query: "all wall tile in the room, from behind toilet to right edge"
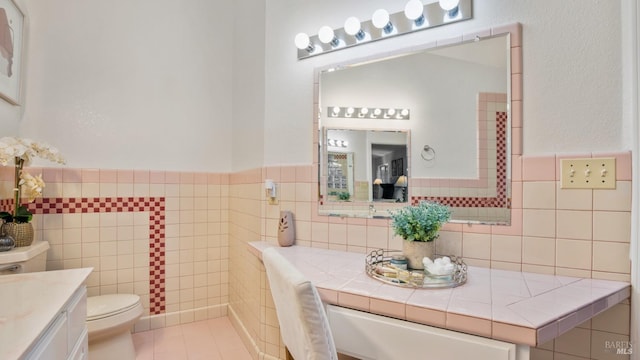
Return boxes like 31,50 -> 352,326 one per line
0,153 -> 631,360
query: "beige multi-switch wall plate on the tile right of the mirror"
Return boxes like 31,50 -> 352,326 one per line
560,158 -> 616,189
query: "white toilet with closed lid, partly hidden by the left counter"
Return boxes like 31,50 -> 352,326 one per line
0,241 -> 144,360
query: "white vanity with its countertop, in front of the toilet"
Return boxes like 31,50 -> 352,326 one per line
0,268 -> 93,360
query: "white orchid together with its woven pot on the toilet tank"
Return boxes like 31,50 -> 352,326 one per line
0,137 -> 64,246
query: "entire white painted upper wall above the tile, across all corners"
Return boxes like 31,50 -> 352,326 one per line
0,0 -> 632,171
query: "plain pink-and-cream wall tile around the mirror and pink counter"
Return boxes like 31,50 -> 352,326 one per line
229,153 -> 631,360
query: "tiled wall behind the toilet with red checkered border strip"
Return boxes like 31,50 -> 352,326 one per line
0,167 -> 229,331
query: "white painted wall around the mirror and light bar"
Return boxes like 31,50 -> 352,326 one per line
265,0 -> 632,165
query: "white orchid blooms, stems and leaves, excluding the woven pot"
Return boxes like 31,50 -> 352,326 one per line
0,137 -> 64,223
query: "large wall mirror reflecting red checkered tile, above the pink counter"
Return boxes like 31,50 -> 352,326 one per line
315,28 -> 512,224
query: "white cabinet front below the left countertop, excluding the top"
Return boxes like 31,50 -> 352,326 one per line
23,285 -> 89,360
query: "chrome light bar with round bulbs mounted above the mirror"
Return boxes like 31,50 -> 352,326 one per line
295,0 -> 473,60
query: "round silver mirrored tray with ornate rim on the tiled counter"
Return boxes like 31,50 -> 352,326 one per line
365,249 -> 467,289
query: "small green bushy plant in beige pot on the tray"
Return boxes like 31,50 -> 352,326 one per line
391,201 -> 451,269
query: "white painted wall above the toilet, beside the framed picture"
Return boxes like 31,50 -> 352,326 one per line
8,0 -> 234,171
